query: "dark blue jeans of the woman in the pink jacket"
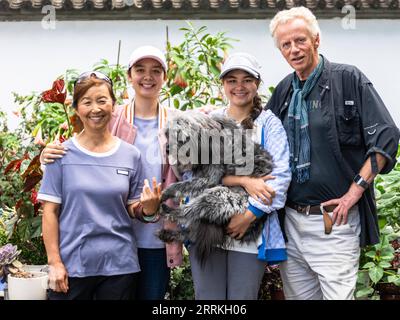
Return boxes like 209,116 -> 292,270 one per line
135,248 -> 169,300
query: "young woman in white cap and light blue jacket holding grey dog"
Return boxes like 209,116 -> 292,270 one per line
189,53 -> 291,300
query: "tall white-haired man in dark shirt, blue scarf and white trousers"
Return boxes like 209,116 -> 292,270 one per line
267,7 -> 399,300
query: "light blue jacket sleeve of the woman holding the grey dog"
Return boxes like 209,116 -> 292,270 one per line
248,111 -> 292,217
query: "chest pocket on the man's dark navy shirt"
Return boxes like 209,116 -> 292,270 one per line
336,101 -> 361,146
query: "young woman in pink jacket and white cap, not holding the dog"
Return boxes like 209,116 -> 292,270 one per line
41,46 -> 182,300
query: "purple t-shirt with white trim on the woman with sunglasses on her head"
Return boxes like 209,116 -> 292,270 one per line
38,138 -> 143,277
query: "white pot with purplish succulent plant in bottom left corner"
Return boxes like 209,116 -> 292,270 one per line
0,244 -> 48,300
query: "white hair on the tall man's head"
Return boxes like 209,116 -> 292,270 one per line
269,7 -> 321,48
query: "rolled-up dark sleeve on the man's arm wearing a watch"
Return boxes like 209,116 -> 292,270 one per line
360,76 -> 400,173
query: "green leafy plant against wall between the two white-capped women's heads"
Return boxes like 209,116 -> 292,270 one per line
162,22 -> 236,110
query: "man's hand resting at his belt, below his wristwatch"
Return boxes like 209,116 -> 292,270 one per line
322,183 -> 364,226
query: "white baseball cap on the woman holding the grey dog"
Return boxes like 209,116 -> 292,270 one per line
219,52 -> 261,79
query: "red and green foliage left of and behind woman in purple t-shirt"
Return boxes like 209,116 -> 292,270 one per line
0,60 -> 126,264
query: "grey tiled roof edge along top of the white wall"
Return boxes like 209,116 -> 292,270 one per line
0,0 -> 400,20
